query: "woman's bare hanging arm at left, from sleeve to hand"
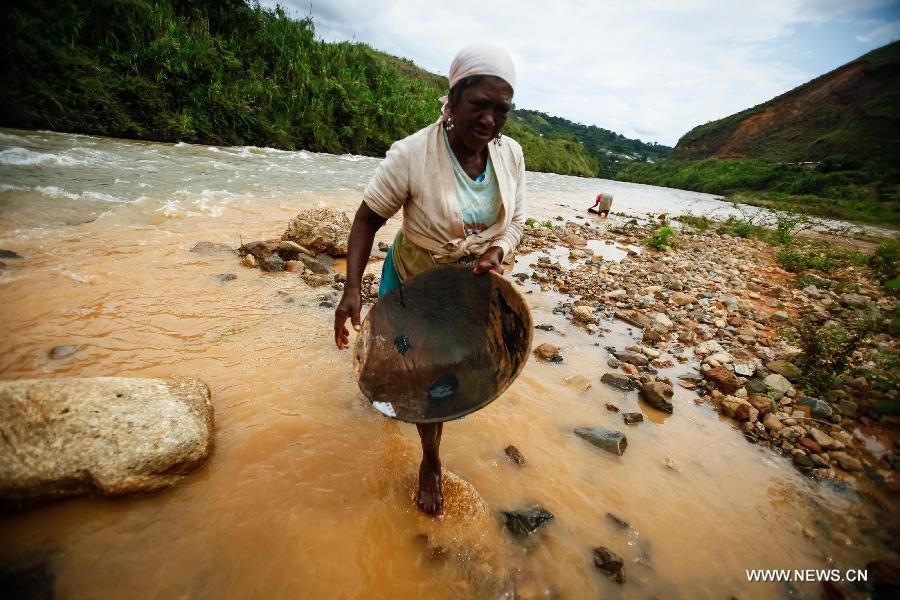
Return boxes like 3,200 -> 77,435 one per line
334,202 -> 387,348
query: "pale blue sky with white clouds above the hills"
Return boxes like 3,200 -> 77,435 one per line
262,0 -> 900,146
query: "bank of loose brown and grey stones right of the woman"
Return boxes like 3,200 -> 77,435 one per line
518,213 -> 900,491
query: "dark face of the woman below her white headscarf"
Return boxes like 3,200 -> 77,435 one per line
448,76 -> 513,152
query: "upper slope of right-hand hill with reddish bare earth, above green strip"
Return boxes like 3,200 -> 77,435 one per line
672,42 -> 900,169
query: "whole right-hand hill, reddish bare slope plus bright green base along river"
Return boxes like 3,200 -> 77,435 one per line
616,42 -> 900,227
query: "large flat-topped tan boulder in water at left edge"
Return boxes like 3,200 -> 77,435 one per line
0,377 -> 213,505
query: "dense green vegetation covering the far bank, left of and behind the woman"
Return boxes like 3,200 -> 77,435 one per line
0,0 -> 669,176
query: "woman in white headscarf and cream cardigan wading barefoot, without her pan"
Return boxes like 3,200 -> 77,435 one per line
334,44 -> 525,515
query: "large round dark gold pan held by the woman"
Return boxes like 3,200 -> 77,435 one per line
353,266 -> 532,423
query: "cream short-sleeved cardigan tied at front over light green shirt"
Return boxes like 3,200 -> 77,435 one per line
363,123 -> 525,262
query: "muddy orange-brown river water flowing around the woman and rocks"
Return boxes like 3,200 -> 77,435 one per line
0,130 -> 882,598
